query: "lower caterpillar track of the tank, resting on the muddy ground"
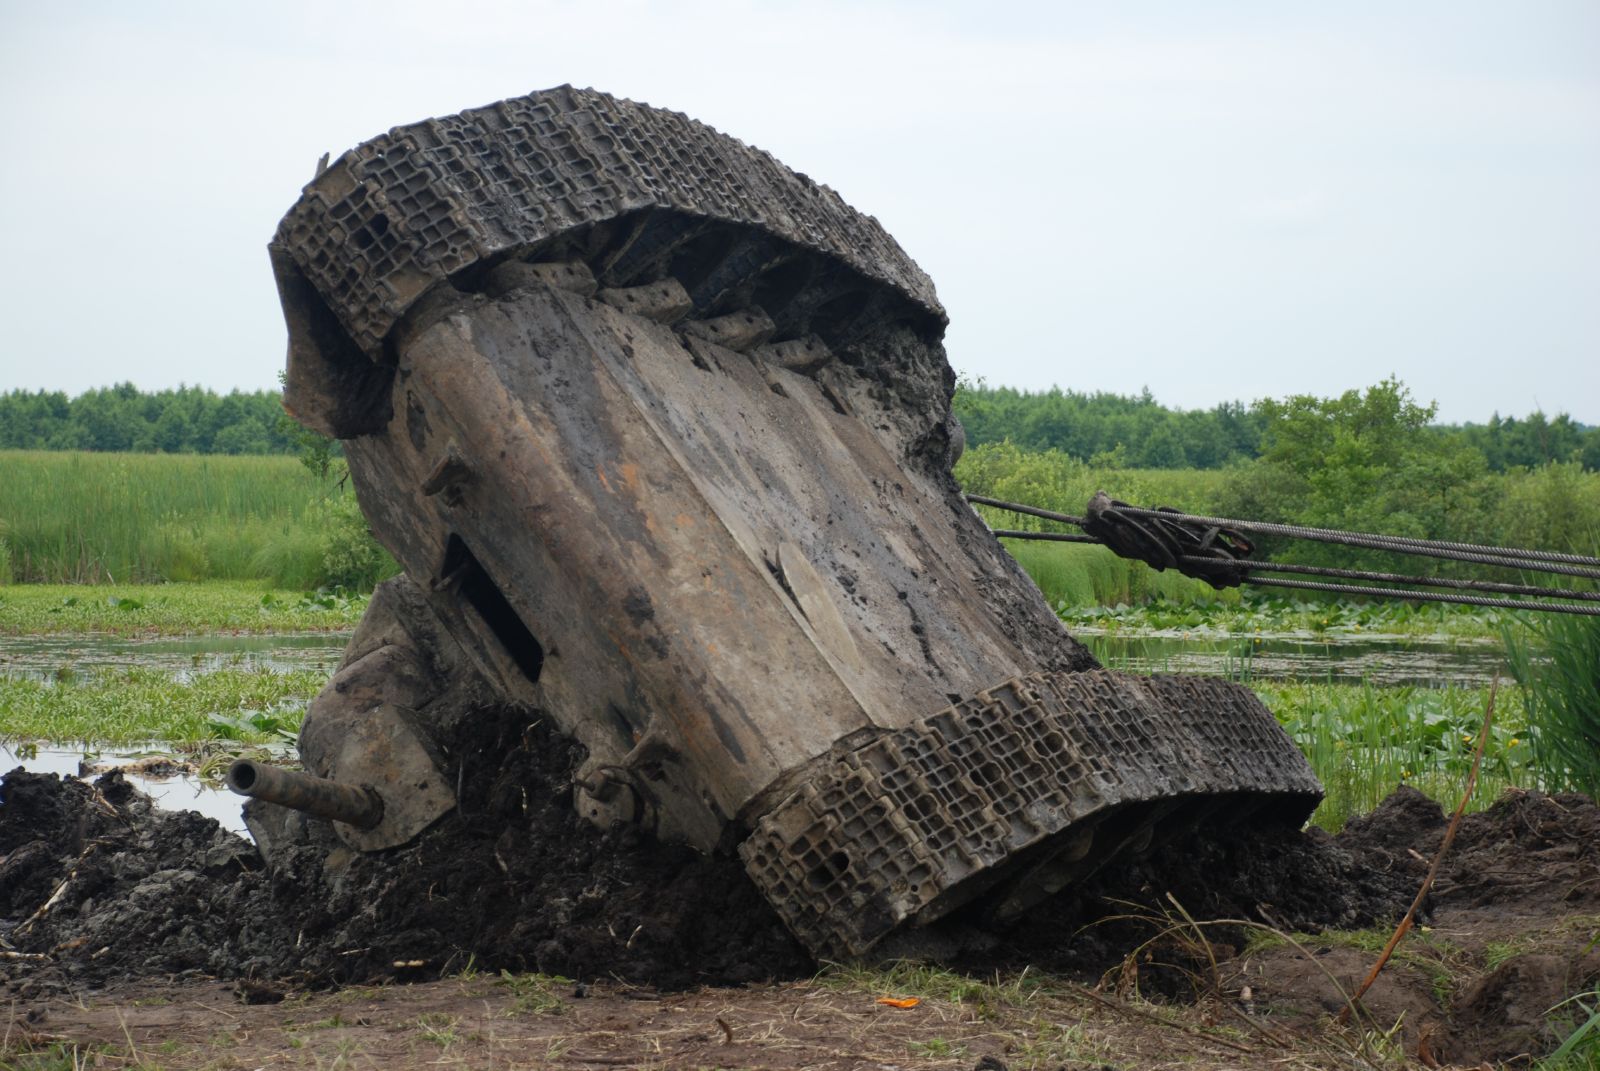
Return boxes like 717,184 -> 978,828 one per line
739,671 -> 1322,957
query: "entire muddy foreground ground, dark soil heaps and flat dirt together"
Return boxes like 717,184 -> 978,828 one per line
0,704 -> 1600,1071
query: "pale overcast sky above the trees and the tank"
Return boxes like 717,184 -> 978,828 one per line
0,0 -> 1600,423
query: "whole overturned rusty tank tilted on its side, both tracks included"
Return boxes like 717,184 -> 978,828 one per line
259,86 -> 1320,956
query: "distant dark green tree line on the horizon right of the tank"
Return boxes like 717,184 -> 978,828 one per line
955,381 -> 1600,472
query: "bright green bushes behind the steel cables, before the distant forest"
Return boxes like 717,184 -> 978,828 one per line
957,379 -> 1600,566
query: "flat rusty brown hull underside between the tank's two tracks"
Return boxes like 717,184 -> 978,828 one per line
347,275 -> 1090,850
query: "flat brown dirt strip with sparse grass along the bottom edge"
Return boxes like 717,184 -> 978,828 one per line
8,977 -> 1472,1071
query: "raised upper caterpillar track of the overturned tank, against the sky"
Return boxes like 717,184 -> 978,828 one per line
272,86 -> 946,360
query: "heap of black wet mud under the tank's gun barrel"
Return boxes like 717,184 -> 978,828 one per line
0,711 -> 813,988
